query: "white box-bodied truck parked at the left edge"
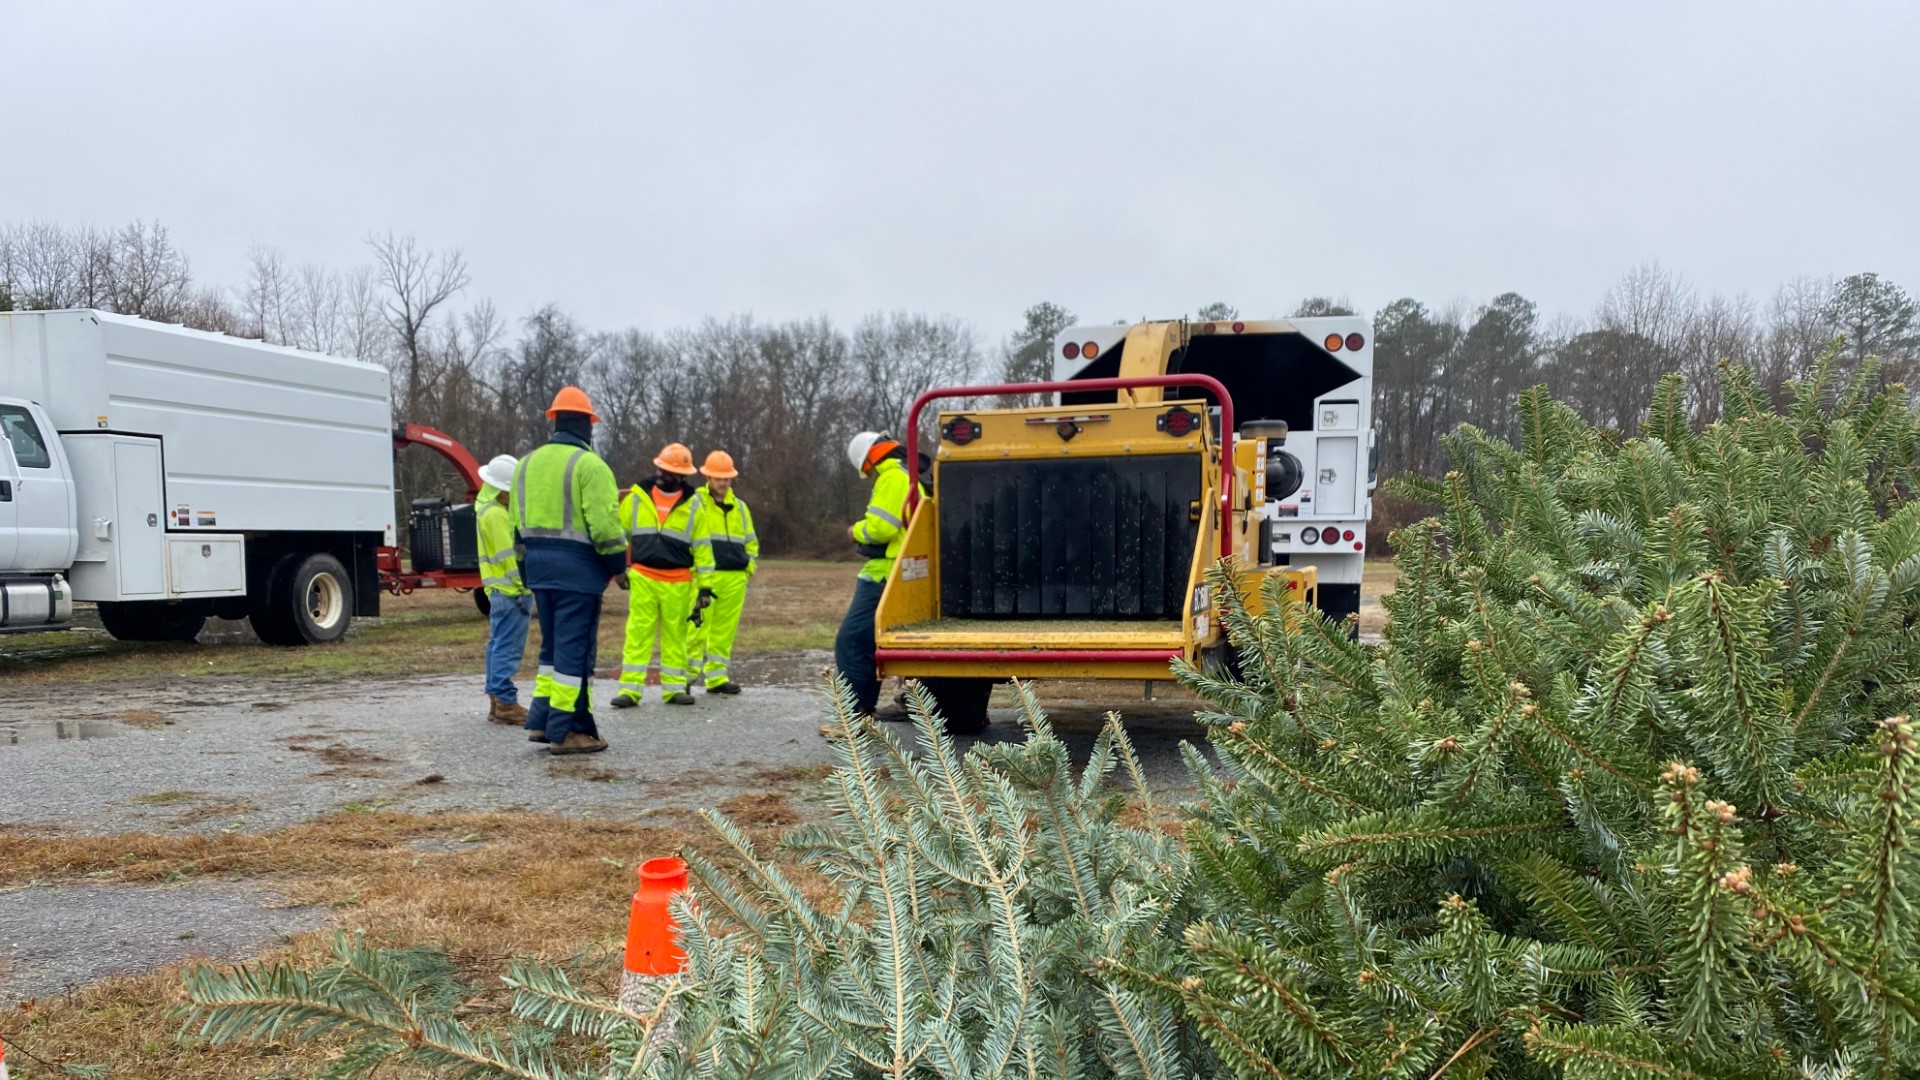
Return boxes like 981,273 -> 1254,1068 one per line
0,311 -> 394,646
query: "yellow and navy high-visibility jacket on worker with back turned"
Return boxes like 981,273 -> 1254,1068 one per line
507,432 -> 626,594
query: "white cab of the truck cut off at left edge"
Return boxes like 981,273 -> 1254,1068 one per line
0,398 -> 79,632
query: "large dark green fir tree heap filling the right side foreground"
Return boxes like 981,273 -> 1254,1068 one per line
1127,356 -> 1920,1078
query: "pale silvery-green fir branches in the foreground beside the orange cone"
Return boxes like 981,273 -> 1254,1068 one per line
188,686 -> 1212,1080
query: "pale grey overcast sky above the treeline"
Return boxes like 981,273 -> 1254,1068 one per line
0,0 -> 1920,338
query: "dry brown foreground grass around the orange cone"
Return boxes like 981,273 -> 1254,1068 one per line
0,796 -> 826,1080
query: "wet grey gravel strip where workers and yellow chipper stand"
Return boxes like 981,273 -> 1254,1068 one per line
0,655 -> 1198,832
